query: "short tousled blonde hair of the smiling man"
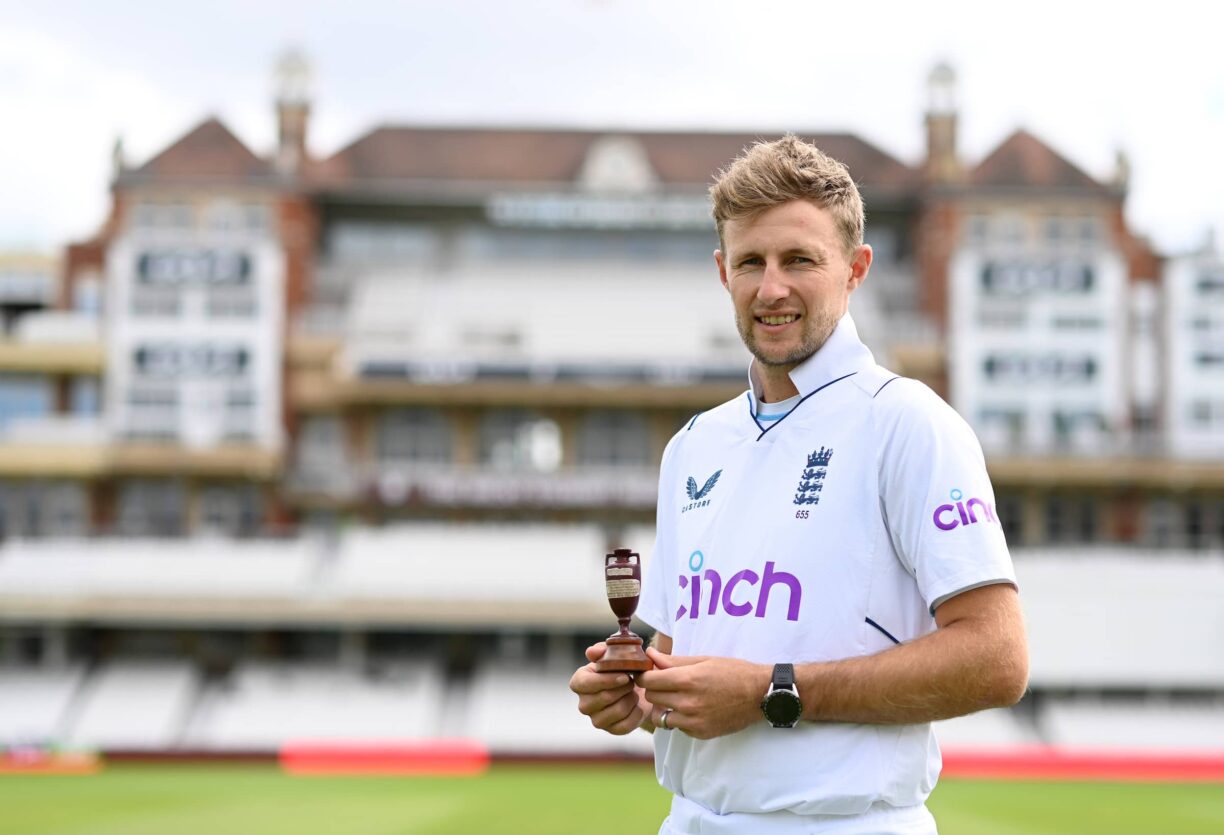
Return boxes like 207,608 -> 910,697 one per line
710,133 -> 865,253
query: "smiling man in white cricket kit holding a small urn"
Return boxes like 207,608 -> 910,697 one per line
570,136 -> 1028,834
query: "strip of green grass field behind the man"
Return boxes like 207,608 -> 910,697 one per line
0,765 -> 1224,835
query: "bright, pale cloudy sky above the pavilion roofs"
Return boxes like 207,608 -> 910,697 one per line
0,0 -> 1224,255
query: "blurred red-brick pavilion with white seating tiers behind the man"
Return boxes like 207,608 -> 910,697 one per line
0,58 -> 1224,751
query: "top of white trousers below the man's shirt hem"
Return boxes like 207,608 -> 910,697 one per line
659,797 -> 936,835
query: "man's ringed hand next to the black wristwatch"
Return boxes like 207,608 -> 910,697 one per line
638,648 -> 772,740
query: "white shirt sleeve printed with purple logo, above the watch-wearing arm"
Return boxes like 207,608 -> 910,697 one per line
876,380 -> 1016,613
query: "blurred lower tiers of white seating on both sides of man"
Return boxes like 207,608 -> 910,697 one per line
0,523 -> 1224,755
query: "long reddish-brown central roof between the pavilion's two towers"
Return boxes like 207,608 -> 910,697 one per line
315,126 -> 917,190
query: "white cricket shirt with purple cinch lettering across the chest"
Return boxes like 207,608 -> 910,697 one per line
638,315 -> 1015,815
